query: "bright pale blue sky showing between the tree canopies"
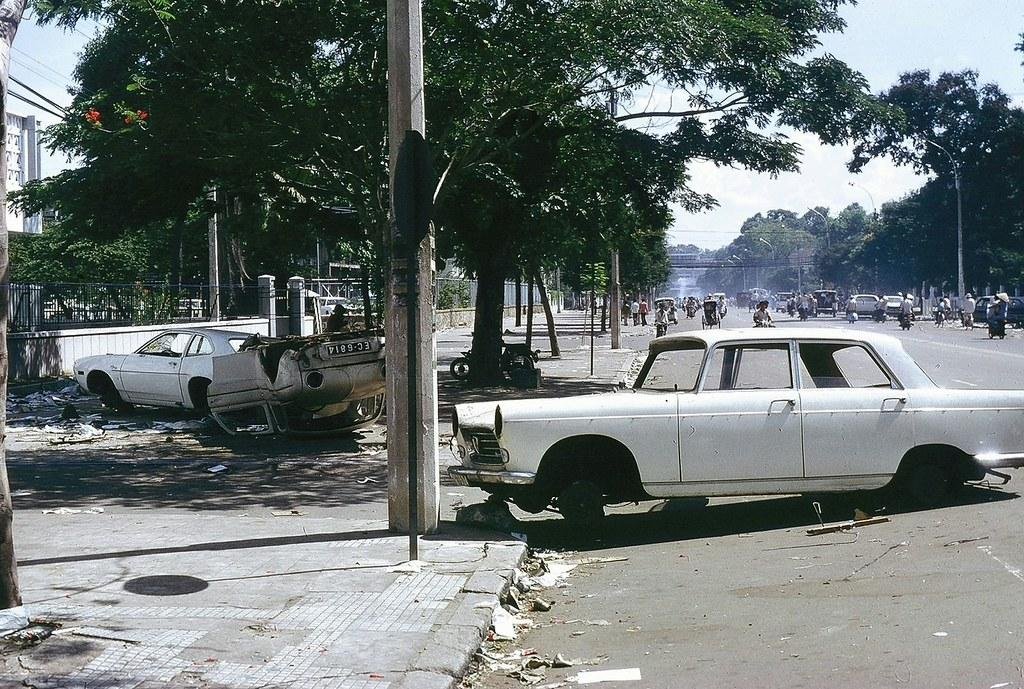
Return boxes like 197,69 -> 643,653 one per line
9,0 -> 1024,249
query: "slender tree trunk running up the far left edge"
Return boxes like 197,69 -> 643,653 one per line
0,0 -> 26,610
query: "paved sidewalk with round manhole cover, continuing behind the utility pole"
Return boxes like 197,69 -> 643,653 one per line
0,312 -> 646,689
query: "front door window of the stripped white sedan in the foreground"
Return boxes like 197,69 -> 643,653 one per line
703,343 -> 793,391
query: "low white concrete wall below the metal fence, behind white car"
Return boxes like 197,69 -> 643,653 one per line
7,318 -> 267,381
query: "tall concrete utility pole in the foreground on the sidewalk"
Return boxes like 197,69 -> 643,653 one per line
385,0 -> 440,544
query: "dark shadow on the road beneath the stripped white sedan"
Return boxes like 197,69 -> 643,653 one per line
521,486 -> 1020,551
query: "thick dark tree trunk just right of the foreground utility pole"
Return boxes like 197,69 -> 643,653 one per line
469,252 -> 506,385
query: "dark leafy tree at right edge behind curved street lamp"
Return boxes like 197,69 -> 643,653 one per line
851,71 -> 1024,289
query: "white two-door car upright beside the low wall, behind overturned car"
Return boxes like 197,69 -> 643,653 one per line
75,329 -> 252,414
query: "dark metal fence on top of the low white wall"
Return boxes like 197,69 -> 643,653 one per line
8,283 -> 259,333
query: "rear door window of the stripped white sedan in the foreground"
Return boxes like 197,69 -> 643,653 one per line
800,342 -> 893,389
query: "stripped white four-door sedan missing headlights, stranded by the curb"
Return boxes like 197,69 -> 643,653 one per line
449,329 -> 1024,524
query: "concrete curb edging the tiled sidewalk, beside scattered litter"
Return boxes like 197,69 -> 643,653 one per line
395,542 -> 528,689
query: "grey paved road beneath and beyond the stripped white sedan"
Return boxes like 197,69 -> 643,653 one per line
468,314 -> 1024,689
